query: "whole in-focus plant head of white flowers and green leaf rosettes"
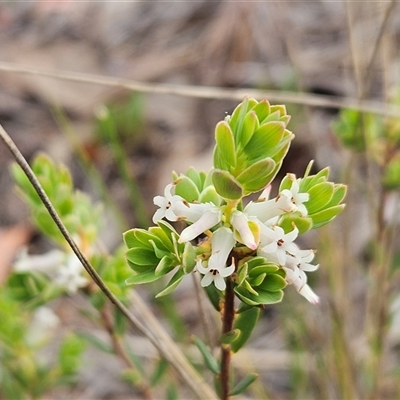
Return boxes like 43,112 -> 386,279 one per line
124,99 -> 346,309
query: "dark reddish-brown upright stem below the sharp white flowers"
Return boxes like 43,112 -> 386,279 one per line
220,279 -> 235,400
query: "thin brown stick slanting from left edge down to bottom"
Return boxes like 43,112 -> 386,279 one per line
0,125 -> 218,400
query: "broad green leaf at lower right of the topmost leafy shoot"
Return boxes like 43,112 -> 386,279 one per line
236,158 -> 276,193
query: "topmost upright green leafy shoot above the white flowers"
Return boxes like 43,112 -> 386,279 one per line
213,99 -> 294,200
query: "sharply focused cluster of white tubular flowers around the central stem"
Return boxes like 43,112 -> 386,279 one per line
153,175 -> 318,304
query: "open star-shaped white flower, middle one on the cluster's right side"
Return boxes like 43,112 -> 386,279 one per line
259,225 -> 299,266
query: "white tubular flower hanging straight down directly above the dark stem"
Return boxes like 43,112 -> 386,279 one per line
196,227 -> 235,290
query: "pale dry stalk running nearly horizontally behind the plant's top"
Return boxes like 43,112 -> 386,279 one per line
0,62 -> 400,117
